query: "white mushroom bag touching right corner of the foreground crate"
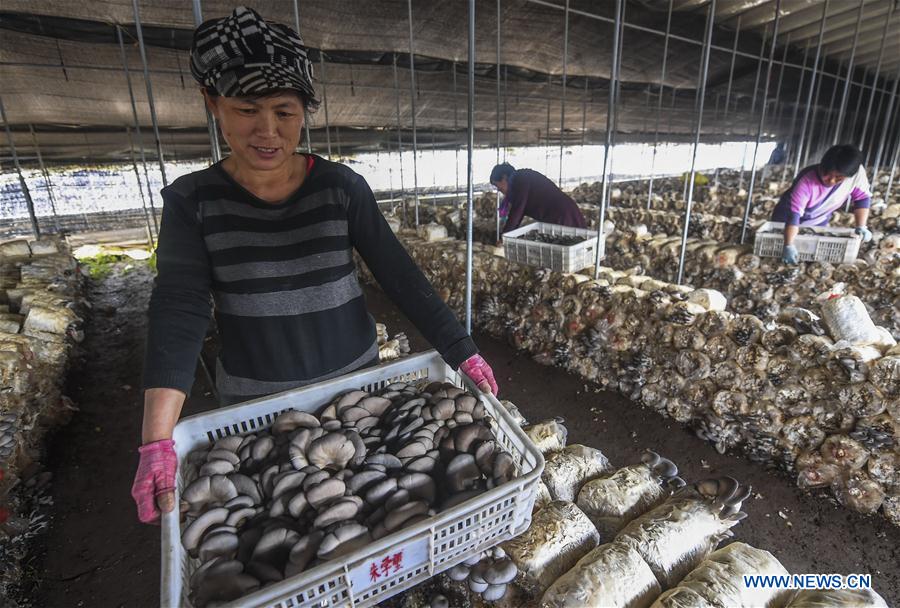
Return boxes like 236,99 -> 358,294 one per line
503,501 -> 600,596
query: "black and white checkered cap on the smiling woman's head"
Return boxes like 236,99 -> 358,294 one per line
191,6 -> 318,106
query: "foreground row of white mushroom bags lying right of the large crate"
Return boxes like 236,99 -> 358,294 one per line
510,419 -> 887,608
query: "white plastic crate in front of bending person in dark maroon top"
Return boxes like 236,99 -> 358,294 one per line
503,222 -> 606,272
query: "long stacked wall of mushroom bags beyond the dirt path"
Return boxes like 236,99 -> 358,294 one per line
361,231 -> 900,524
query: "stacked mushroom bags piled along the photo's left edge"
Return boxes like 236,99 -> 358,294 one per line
0,239 -> 89,592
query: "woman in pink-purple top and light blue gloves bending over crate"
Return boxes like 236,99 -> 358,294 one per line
772,144 -> 872,264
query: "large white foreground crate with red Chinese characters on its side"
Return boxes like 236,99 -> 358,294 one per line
160,351 -> 544,608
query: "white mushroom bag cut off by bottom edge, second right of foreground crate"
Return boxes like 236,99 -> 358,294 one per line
541,542 -> 662,608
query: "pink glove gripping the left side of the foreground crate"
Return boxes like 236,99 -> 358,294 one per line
131,439 -> 178,524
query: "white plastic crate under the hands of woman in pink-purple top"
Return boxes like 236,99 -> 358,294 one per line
753,222 -> 862,264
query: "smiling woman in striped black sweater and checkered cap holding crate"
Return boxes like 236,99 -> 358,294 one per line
132,7 -> 497,523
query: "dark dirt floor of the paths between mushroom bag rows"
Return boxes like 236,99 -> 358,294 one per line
30,264 -> 900,608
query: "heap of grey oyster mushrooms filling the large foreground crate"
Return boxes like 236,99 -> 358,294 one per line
181,383 -> 516,606
